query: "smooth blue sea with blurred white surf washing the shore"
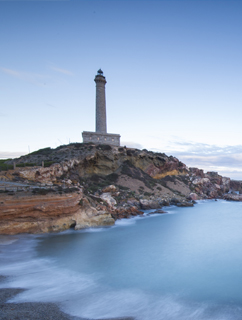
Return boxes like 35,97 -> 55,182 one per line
0,200 -> 242,320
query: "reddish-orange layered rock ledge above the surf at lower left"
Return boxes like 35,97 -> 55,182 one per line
0,190 -> 114,234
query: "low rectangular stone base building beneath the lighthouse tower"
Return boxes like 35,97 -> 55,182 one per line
82,131 -> 120,146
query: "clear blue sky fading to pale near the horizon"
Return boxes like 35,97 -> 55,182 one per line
0,0 -> 242,180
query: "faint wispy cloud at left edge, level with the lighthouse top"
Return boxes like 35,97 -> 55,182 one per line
0,68 -> 50,86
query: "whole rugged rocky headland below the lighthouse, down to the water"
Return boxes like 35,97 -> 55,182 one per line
0,144 -> 241,234
